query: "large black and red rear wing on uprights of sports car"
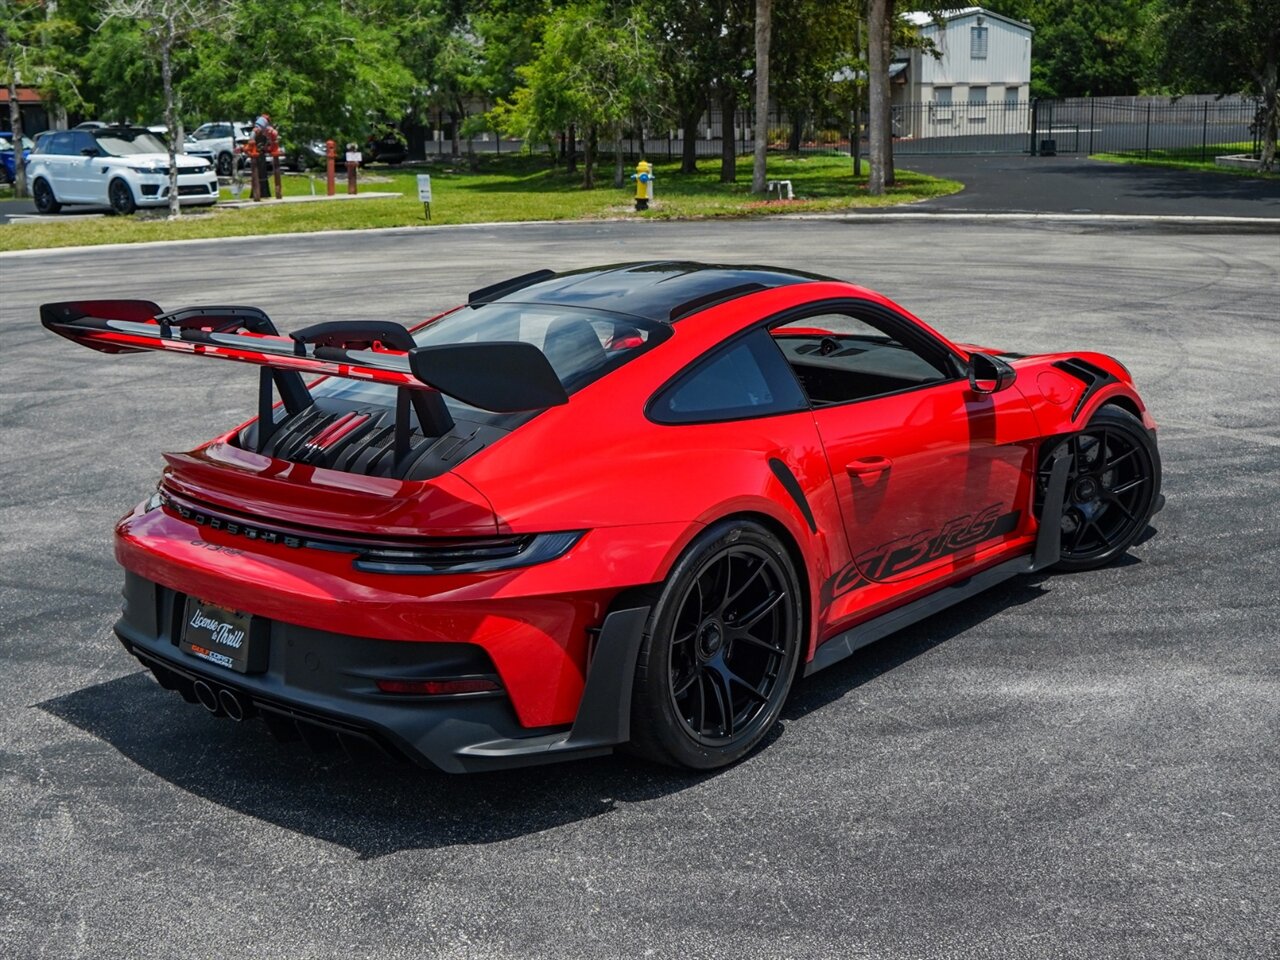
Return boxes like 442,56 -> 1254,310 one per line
40,300 -> 568,463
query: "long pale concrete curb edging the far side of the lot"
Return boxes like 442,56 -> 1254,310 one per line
0,209 -> 1280,260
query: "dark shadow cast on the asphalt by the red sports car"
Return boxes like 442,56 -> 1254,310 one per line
37,570 -> 1070,858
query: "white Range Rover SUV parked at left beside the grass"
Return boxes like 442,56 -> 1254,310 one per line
27,127 -> 218,214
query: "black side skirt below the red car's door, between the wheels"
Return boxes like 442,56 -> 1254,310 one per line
804,456 -> 1070,677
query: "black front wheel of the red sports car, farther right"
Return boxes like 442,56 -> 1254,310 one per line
1037,407 -> 1161,570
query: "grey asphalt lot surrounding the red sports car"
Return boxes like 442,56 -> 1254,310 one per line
0,220 -> 1280,960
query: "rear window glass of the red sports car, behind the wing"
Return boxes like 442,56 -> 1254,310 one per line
314,303 -> 671,419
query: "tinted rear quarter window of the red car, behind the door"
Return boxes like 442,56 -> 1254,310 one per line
649,330 -> 808,424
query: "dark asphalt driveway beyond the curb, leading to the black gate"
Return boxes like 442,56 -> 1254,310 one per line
896,156 -> 1280,217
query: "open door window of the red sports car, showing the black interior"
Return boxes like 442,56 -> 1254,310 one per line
772,311 -> 955,407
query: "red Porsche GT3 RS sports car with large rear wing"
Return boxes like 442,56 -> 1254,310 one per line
41,262 -> 1162,772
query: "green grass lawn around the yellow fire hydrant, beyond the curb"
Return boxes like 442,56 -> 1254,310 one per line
0,155 -> 963,251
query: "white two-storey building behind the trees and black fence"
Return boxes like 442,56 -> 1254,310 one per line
890,6 -> 1034,137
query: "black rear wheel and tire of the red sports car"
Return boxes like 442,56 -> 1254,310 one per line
631,520 -> 804,769
